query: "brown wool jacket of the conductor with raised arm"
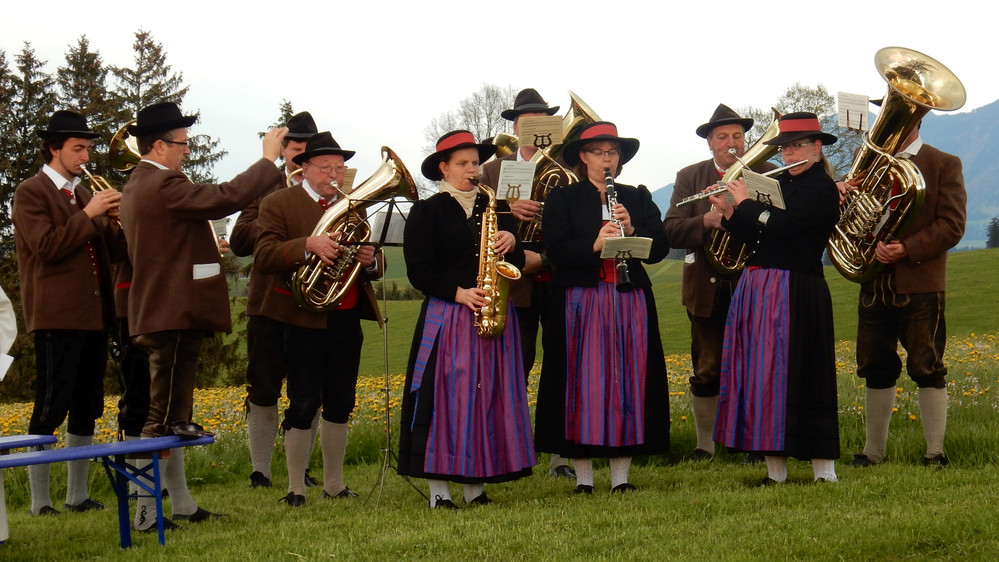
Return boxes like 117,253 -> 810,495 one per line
122,158 -> 281,336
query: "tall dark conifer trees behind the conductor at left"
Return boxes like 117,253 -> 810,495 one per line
0,29 -> 243,402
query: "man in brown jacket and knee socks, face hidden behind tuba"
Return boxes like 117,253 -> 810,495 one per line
840,126 -> 968,467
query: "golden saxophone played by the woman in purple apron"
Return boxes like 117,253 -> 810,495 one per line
471,178 -> 520,338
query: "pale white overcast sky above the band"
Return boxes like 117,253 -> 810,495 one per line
0,0 -> 999,199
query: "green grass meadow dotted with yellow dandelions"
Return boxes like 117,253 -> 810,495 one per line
0,250 -> 999,561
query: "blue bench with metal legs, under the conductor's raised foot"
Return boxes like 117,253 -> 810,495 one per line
0,435 -> 215,548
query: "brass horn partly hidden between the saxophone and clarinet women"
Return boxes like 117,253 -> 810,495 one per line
518,91 -> 600,242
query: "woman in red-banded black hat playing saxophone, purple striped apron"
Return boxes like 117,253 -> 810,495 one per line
399,131 -> 535,509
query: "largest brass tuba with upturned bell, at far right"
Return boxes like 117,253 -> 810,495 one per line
827,47 -> 967,283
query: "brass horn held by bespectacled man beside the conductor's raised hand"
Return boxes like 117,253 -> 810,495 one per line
291,146 -> 417,311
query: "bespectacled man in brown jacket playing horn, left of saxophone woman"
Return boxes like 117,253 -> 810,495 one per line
253,132 -> 378,507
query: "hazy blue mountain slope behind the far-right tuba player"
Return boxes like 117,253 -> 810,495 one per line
652,101 -> 999,249
